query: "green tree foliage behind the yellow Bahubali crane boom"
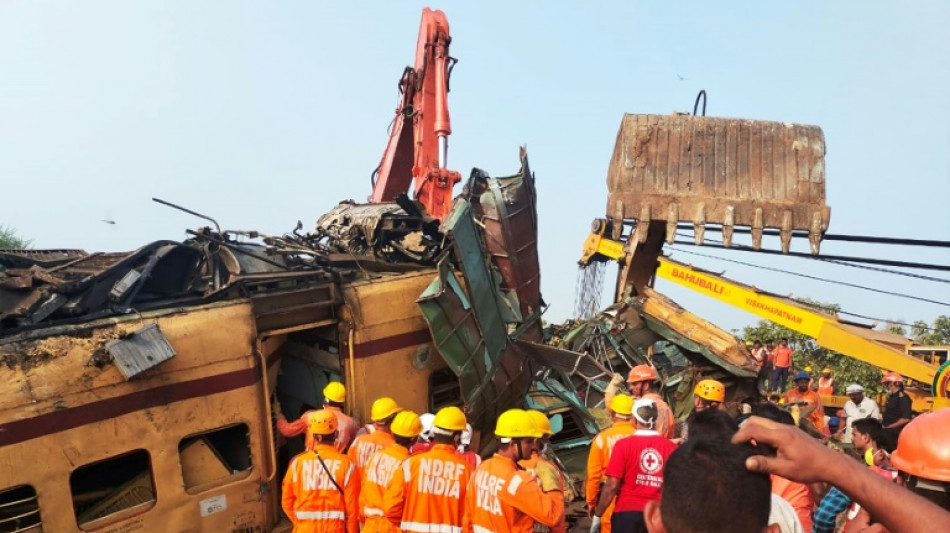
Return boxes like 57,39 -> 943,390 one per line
742,301 -> 883,397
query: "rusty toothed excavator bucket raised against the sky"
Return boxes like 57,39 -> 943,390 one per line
607,115 -> 831,254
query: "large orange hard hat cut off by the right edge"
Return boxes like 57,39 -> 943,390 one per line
891,408 -> 950,482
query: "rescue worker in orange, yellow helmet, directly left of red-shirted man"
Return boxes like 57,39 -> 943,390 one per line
584,394 -> 636,533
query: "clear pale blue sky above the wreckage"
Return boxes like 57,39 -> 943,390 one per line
0,0 -> 950,329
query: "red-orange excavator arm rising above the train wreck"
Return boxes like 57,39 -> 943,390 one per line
370,8 -> 462,220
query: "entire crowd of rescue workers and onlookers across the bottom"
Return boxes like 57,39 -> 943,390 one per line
278,365 -> 950,533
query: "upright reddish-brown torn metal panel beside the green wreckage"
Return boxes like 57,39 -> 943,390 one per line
469,149 -> 543,341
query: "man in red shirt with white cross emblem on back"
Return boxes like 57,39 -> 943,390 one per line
594,398 -> 676,533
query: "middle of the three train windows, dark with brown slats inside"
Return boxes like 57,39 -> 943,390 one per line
69,450 -> 155,530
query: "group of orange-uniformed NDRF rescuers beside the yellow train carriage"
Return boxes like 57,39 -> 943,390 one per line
277,382 -> 567,533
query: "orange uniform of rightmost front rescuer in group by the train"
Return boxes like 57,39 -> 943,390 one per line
463,454 -> 564,533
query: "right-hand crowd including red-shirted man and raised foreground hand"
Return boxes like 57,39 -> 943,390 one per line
585,367 -> 950,533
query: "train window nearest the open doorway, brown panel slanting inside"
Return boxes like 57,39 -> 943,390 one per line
178,424 -> 251,494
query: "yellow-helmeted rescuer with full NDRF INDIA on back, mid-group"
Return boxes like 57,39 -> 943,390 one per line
383,407 -> 472,533
